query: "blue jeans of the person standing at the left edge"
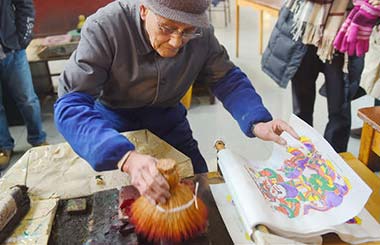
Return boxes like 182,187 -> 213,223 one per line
0,50 -> 46,150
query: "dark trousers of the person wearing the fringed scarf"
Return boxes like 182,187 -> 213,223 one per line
292,46 -> 351,152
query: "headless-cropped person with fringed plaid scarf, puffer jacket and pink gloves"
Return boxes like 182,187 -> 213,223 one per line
262,0 -> 380,152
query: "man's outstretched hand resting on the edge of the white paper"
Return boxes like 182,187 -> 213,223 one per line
253,119 -> 299,145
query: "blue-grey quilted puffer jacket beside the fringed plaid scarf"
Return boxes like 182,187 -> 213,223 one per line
261,7 -> 307,88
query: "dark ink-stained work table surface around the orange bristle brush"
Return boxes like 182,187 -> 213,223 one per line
49,174 -> 233,245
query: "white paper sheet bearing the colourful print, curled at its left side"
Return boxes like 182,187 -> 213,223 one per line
218,116 -> 371,241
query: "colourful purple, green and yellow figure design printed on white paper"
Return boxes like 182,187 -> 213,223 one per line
247,136 -> 351,218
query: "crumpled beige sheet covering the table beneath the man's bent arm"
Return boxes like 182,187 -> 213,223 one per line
0,130 -> 194,199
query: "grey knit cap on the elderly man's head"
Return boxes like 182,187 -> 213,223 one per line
141,0 -> 209,27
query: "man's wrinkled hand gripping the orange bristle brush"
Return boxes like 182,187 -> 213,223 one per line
122,151 -> 170,204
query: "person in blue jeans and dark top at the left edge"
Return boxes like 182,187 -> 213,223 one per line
0,0 -> 46,171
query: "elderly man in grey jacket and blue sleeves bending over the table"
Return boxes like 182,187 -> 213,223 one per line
55,0 -> 297,202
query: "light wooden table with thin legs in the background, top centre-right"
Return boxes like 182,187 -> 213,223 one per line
236,0 -> 283,57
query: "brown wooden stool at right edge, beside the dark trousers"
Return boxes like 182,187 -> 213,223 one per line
358,106 -> 380,169
